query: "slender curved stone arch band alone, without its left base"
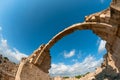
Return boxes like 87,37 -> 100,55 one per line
34,22 -> 117,65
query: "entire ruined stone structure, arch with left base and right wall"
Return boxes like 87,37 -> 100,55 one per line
15,0 -> 120,80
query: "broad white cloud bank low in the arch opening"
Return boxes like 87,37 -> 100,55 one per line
50,55 -> 102,76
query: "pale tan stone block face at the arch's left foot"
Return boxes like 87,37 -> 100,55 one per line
15,59 -> 50,80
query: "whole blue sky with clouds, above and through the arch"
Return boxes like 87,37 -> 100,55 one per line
0,0 -> 111,76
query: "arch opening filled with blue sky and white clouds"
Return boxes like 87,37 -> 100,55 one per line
50,30 -> 106,77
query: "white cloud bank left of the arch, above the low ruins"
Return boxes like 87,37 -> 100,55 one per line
0,27 -> 28,63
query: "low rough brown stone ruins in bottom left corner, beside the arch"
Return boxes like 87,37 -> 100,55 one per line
0,55 -> 18,80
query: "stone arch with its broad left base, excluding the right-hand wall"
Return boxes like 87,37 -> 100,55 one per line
15,22 -> 118,80
